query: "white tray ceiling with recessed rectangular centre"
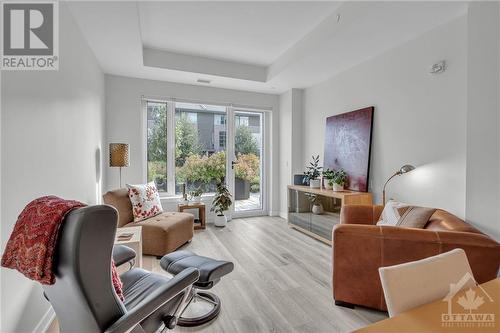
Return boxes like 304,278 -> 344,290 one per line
67,1 -> 467,94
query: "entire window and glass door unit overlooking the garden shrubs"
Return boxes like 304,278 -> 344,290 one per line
143,100 -> 263,202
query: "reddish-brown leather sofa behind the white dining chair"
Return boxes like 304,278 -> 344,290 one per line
332,205 -> 500,311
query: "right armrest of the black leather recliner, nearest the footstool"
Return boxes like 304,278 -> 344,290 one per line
105,268 -> 200,333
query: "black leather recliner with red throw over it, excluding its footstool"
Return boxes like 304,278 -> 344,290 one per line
43,205 -> 199,333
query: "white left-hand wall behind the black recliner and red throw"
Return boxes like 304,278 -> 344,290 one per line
0,4 -> 104,332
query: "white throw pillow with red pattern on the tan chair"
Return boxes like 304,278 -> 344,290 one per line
127,182 -> 163,222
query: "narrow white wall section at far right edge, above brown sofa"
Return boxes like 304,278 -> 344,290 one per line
466,2 -> 500,240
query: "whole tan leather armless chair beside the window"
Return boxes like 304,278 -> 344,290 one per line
103,189 -> 194,257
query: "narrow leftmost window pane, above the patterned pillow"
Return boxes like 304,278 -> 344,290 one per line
146,101 -> 167,192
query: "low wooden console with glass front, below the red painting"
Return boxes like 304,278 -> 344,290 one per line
288,185 -> 373,245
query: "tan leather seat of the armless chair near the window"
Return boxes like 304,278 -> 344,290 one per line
125,212 -> 194,256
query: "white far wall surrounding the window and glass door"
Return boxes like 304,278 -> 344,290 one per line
105,75 -> 279,215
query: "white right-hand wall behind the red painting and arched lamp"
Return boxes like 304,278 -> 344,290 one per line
302,17 -> 467,217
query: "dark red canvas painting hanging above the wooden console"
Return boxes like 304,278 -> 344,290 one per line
323,106 -> 374,192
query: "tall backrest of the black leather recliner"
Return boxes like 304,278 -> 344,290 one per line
43,205 -> 126,332
